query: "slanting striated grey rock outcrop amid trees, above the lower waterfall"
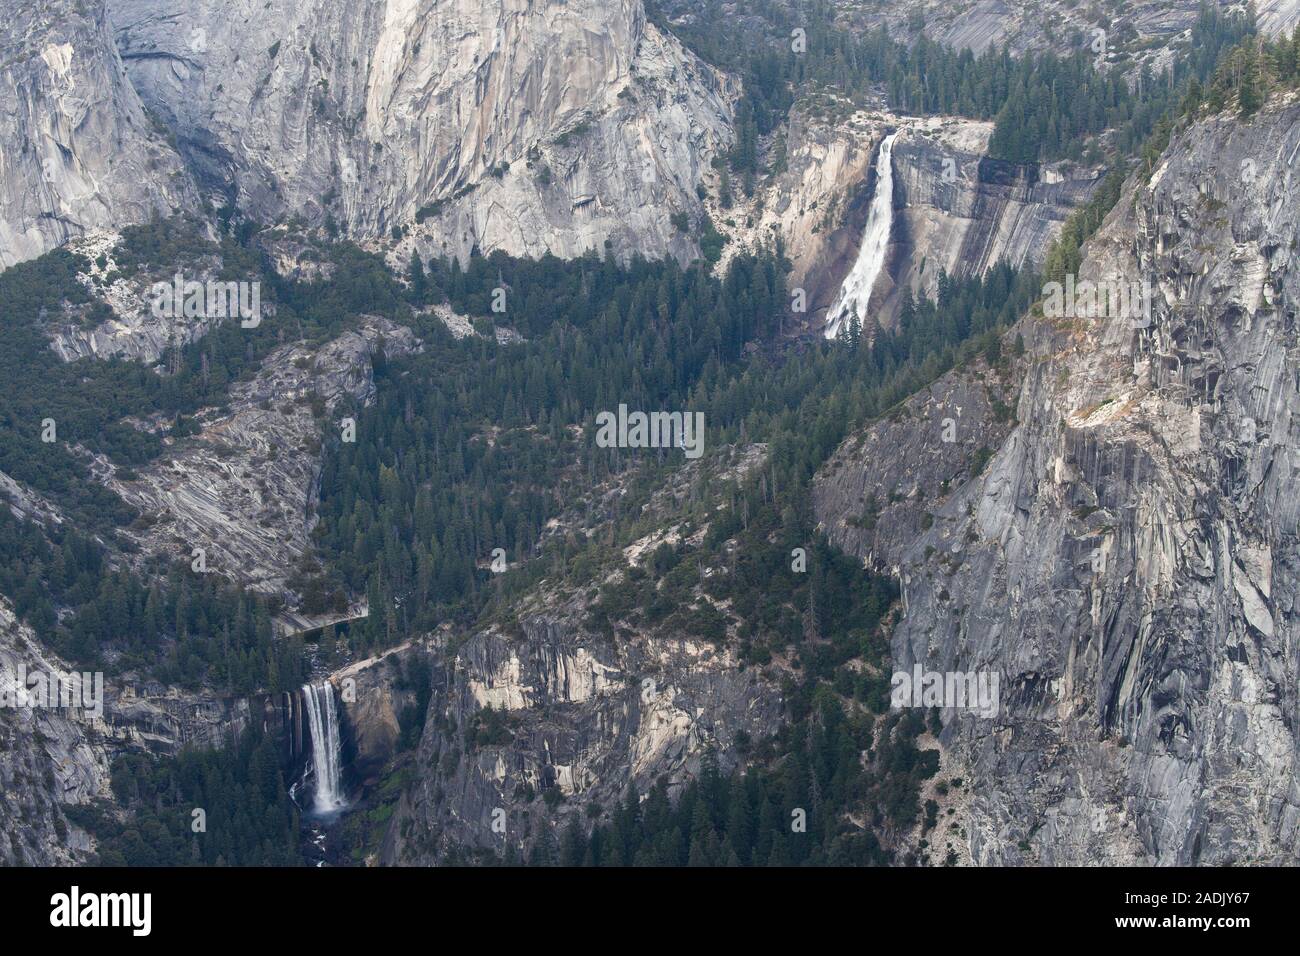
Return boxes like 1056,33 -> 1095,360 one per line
106,316 -> 420,606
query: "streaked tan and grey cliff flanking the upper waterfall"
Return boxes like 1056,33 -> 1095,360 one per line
715,111 -> 1099,325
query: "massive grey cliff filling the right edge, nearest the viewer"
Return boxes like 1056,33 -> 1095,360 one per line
819,99 -> 1300,864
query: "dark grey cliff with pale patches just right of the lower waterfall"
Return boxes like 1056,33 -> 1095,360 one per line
382,601 -> 783,865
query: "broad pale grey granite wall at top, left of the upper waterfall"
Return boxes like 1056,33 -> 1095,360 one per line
111,0 -> 733,258
